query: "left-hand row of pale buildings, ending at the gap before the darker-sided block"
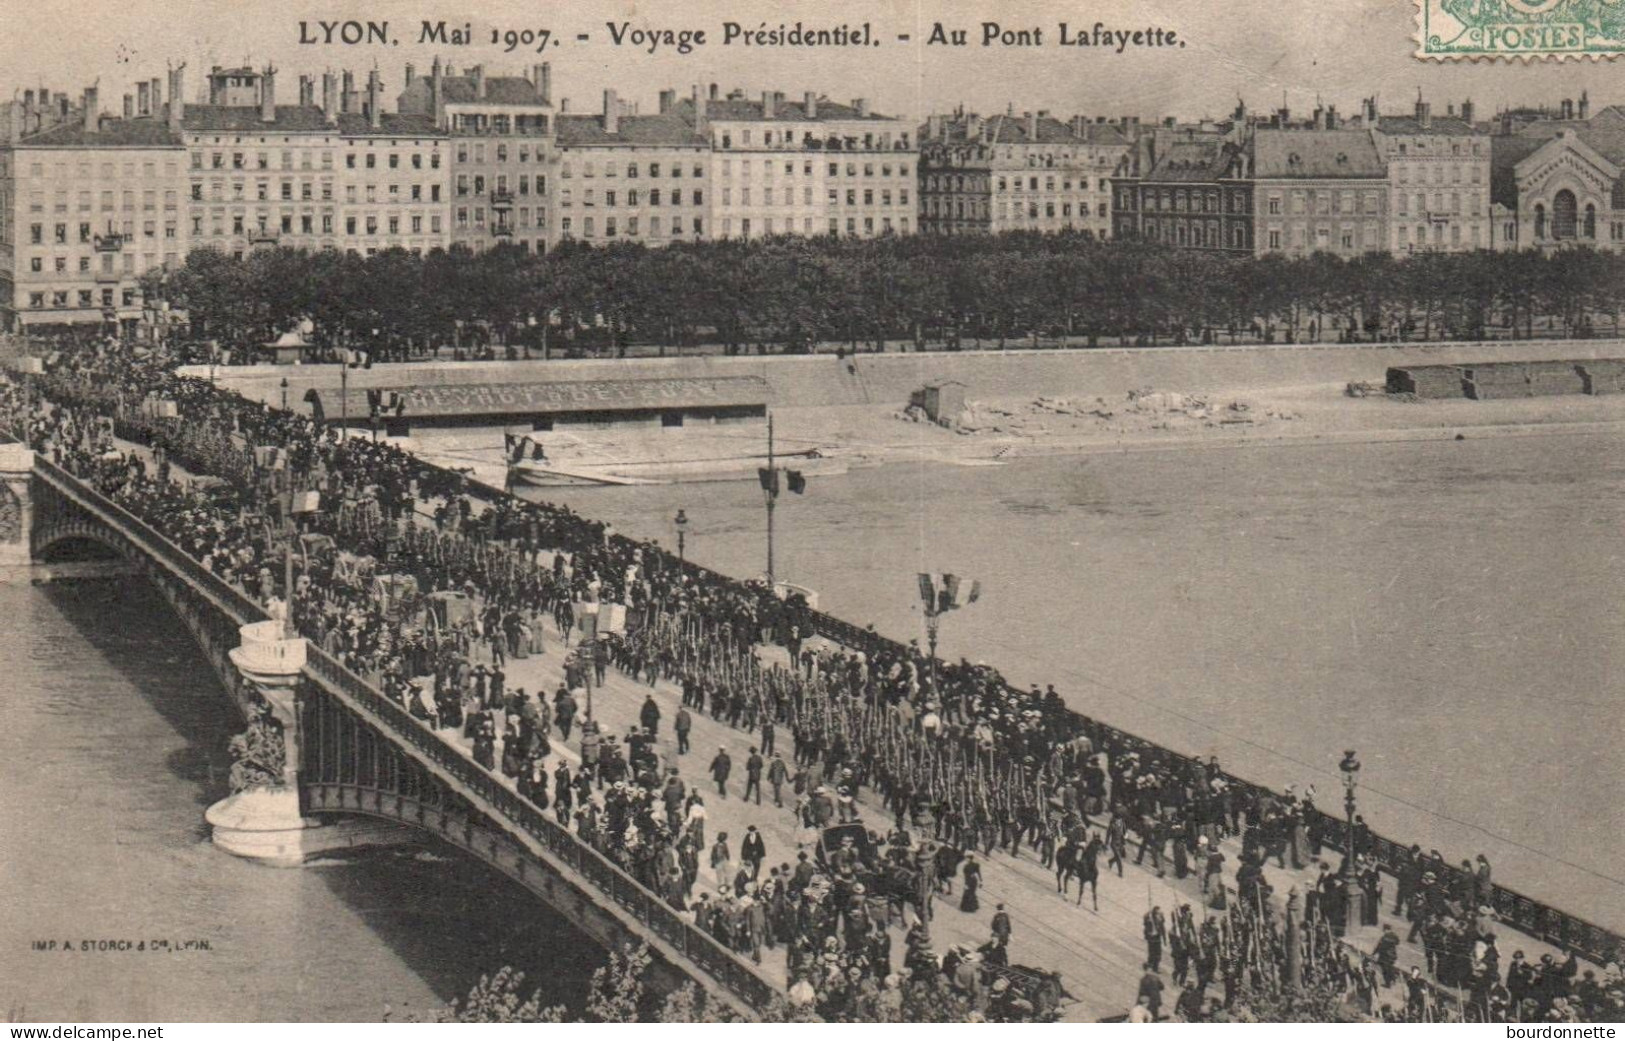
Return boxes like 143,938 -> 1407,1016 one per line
0,60 -> 918,328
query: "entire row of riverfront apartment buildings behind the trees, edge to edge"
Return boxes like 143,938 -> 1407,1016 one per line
0,60 -> 1625,328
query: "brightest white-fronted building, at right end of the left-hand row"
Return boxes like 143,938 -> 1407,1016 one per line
661,83 -> 920,239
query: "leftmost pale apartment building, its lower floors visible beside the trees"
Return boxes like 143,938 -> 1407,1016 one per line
0,81 -> 190,331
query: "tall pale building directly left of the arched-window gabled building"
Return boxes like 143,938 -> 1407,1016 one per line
1365,99 -> 1492,255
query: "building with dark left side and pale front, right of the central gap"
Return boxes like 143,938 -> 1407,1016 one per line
920,112 -> 1129,239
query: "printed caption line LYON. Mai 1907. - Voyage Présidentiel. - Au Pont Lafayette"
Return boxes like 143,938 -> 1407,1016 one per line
297,18 -> 1185,54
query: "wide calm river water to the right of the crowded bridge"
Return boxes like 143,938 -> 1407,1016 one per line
553,425 -> 1625,929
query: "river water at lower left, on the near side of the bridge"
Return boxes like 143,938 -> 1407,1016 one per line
0,580 -> 600,1022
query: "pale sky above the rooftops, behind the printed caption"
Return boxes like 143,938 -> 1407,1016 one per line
0,0 -> 1625,120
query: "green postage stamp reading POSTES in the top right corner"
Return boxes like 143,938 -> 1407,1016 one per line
1415,0 -> 1625,60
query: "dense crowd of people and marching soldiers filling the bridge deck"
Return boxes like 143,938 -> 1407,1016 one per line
5,334 -> 1625,1022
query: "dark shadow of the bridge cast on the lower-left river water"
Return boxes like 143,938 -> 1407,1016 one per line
39,578 -> 606,1018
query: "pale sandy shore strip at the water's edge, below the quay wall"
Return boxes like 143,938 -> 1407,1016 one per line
352,383 -> 1625,486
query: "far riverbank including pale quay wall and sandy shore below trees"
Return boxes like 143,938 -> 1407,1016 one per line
206,339 -> 1625,486
